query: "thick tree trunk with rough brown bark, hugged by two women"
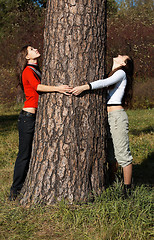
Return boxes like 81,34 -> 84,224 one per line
21,0 -> 106,205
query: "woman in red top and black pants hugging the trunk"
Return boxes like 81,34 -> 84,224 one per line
9,46 -> 71,200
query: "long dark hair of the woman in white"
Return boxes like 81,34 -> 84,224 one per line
108,57 -> 134,107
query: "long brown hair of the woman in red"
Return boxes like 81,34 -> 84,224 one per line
16,45 -> 29,90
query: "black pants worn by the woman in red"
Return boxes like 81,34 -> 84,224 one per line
11,111 -> 35,195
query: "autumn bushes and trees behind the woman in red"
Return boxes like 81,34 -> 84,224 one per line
0,0 -> 44,104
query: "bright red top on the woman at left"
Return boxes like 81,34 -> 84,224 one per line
22,66 -> 41,108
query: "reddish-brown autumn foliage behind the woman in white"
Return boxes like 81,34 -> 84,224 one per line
107,0 -> 154,109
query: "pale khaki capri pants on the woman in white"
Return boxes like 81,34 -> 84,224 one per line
108,109 -> 133,167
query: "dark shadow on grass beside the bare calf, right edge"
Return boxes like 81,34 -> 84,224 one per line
133,152 -> 154,186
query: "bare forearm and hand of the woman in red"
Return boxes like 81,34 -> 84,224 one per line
37,84 -> 72,95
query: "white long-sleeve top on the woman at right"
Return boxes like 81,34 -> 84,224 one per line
90,69 -> 127,105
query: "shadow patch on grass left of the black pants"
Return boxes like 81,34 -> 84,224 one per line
0,114 -> 19,133
